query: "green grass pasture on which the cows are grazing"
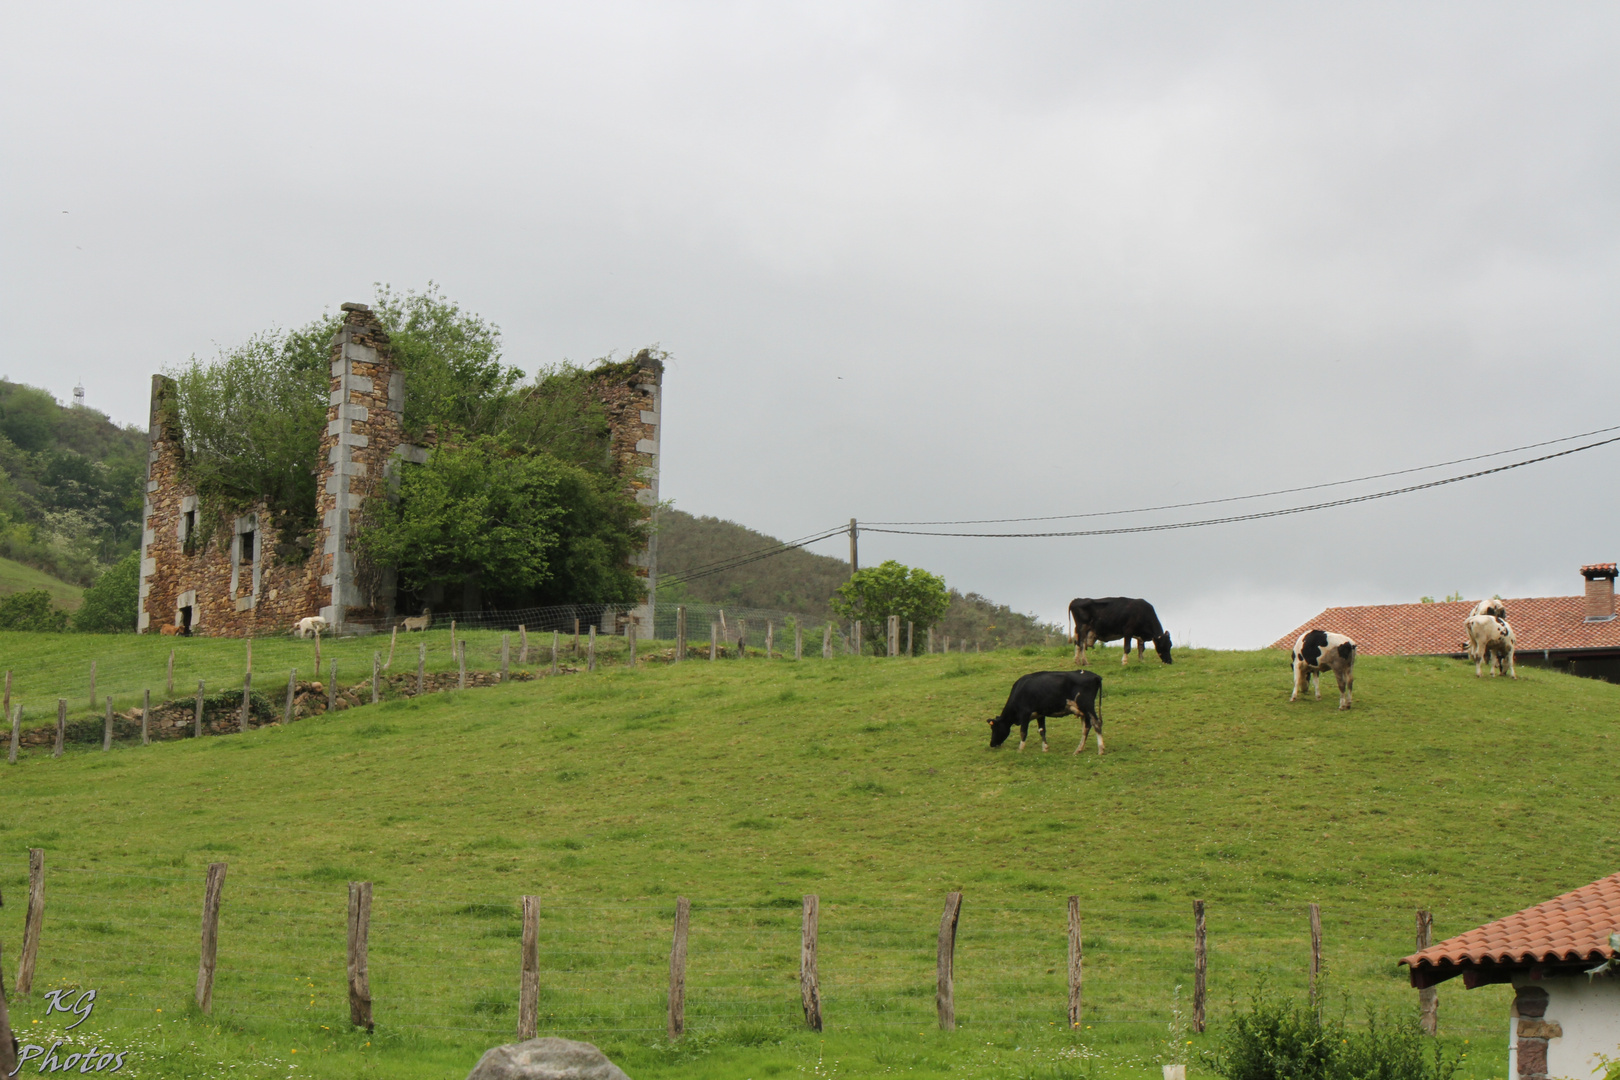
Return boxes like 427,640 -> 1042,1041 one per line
0,631 -> 1620,1080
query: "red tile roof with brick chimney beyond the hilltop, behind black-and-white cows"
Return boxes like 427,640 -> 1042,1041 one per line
1272,596 -> 1620,656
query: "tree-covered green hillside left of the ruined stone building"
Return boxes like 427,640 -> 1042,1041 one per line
0,381 -> 146,585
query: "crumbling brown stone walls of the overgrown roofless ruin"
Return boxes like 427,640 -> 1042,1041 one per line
136,303 -> 664,638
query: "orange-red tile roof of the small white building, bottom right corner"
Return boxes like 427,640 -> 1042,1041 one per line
1401,874 -> 1620,978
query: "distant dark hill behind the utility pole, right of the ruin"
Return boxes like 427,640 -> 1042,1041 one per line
658,508 -> 1063,649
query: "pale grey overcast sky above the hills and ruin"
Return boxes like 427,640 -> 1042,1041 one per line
0,0 -> 1620,646
